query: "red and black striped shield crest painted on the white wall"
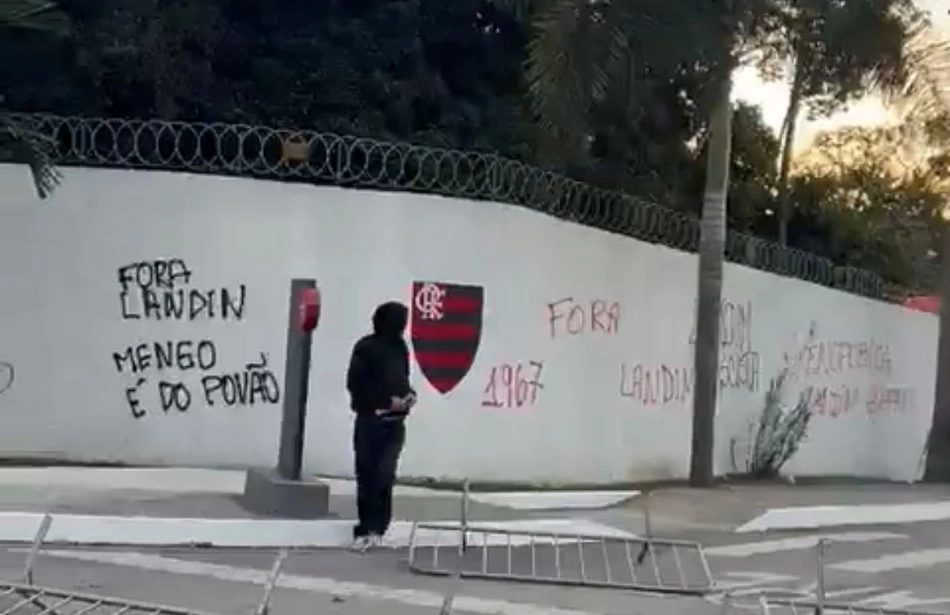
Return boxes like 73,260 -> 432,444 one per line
410,282 -> 485,395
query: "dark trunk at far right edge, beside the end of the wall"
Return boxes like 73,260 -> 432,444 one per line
924,222 -> 950,482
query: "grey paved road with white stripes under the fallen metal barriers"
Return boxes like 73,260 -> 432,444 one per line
0,522 -> 950,615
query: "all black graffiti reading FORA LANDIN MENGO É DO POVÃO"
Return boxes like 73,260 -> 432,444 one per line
112,258 -> 280,419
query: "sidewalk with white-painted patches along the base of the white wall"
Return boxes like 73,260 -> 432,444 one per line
0,467 -> 950,547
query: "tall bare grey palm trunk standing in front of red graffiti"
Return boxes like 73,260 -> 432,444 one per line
689,73 -> 732,487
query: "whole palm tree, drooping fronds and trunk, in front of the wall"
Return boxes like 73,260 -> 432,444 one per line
495,0 -> 749,485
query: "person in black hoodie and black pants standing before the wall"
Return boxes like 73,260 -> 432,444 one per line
346,301 -> 416,551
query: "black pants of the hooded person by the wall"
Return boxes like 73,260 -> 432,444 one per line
353,414 -> 406,537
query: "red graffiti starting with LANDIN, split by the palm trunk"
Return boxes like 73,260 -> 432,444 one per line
620,300 -> 762,406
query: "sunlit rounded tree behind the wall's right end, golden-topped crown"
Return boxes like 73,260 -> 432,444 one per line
791,124 -> 950,289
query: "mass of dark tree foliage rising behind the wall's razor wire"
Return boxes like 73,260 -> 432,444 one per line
0,0 -> 950,292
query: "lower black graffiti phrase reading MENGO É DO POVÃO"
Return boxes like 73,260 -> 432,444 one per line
112,340 -> 280,419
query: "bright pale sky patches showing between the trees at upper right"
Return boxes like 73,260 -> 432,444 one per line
733,0 -> 950,150
